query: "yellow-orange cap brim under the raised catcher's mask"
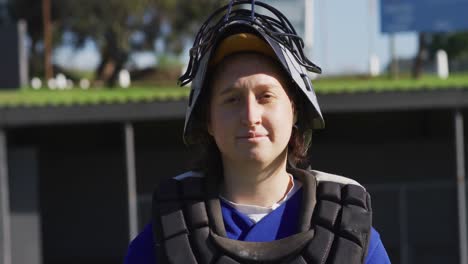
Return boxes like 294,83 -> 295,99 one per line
209,33 -> 276,66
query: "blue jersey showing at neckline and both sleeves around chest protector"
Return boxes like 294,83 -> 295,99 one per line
125,190 -> 390,264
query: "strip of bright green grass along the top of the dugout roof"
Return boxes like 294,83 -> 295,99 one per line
0,74 -> 468,107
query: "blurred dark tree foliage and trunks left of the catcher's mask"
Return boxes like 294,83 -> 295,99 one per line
10,0 -> 227,86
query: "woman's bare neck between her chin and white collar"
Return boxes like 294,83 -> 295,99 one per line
222,151 -> 292,207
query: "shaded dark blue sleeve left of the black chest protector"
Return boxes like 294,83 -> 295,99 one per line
125,224 -> 156,264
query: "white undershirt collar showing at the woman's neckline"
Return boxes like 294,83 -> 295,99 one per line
219,174 -> 302,223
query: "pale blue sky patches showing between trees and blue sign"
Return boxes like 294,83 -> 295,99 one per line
54,0 -> 417,75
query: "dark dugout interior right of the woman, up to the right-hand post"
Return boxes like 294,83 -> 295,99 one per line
311,111 -> 458,263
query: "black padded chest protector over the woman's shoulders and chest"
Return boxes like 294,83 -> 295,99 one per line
153,169 -> 372,264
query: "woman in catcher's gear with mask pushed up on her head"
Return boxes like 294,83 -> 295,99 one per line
126,1 -> 390,263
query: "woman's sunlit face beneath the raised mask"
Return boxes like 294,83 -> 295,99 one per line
208,53 -> 294,165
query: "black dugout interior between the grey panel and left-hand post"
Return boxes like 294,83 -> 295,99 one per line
9,125 -> 128,264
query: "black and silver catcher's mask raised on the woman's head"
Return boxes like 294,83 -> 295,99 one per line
179,0 -> 325,145
